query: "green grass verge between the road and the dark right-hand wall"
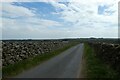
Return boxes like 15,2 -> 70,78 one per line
84,44 -> 118,78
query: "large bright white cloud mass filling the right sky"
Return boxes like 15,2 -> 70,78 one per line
48,0 -> 118,37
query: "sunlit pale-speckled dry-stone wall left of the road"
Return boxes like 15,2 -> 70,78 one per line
2,40 -> 69,67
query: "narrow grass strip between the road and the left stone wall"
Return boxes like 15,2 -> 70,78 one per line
2,43 -> 78,78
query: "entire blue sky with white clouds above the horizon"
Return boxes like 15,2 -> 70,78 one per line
0,0 -> 118,39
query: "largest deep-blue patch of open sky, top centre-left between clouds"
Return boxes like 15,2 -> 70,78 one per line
13,2 -> 62,21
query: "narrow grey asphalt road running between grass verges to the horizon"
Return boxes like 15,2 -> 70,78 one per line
15,43 -> 84,78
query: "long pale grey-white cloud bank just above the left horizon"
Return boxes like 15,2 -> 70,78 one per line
2,18 -> 65,39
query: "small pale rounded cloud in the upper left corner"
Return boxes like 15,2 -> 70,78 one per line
2,3 -> 35,18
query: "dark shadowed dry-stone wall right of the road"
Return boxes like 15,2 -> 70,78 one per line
89,42 -> 120,73
